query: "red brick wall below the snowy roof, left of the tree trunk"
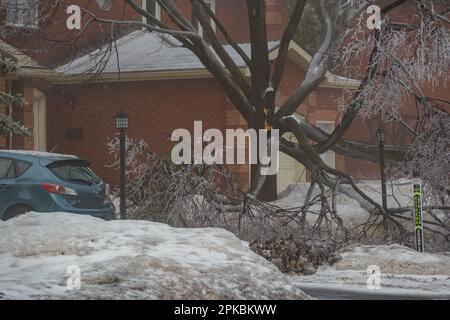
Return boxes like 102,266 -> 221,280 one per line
48,79 -> 226,183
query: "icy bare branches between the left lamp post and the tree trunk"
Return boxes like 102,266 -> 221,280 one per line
107,138 -> 242,231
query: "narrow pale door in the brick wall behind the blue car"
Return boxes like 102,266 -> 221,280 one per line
33,89 -> 47,151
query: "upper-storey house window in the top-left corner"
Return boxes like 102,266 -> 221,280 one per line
6,0 -> 39,27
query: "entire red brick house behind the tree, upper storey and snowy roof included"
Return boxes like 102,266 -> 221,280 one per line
0,0 -> 442,191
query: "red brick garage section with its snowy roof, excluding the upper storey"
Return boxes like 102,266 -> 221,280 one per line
49,31 -> 358,190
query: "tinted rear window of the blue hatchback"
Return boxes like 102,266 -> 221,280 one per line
47,160 -> 100,185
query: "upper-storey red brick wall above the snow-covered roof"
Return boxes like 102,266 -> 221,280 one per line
0,0 -> 288,67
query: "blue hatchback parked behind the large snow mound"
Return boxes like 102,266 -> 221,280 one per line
0,150 -> 115,220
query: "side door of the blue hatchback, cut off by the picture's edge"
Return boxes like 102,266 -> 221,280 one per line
0,158 -> 16,218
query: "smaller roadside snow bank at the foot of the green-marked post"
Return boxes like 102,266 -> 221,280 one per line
293,244 -> 450,299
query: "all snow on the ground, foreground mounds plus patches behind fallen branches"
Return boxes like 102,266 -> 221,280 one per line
0,182 -> 450,299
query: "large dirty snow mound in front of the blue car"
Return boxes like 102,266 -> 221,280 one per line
0,213 -> 307,299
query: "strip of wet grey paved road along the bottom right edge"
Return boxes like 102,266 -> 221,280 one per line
302,288 -> 450,300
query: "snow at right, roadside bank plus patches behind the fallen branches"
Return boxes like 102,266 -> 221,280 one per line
276,180 -> 450,299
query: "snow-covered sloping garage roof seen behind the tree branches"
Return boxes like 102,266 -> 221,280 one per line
53,30 -> 359,88
